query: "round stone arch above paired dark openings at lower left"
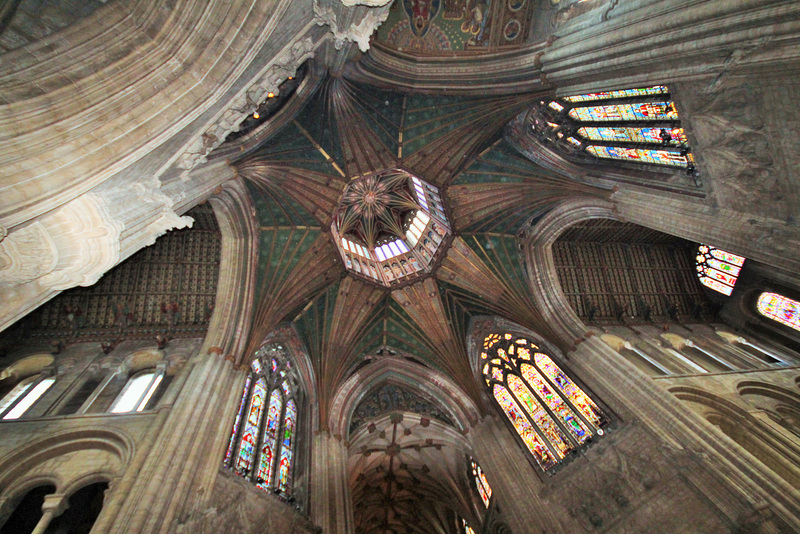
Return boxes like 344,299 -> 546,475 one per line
0,430 -> 134,504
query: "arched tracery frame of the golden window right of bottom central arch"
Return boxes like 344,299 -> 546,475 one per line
478,332 -> 611,473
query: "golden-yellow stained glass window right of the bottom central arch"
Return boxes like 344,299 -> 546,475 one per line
483,334 -> 608,470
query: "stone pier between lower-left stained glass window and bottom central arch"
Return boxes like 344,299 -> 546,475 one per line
311,431 -> 354,534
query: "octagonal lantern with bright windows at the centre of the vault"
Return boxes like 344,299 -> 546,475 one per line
331,169 -> 450,287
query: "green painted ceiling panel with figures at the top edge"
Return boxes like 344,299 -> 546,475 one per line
376,0 -> 533,55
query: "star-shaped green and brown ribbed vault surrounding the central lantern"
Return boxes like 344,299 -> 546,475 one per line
234,77 -> 608,425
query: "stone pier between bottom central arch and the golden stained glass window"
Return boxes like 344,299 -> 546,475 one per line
468,415 -> 564,534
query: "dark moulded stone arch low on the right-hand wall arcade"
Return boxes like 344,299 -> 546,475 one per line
670,386 -> 800,488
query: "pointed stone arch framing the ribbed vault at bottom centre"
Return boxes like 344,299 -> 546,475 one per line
329,356 -> 479,437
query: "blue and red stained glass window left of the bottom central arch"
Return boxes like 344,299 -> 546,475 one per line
224,345 -> 298,496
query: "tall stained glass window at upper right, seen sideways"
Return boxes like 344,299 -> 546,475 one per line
530,85 -> 694,173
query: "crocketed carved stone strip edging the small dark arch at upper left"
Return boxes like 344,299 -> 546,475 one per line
177,37 -> 316,180
